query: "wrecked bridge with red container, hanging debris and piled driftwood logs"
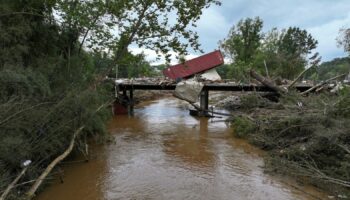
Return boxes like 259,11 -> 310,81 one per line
113,50 -> 349,116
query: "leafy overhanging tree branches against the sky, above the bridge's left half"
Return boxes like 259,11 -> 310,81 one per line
58,0 -> 220,63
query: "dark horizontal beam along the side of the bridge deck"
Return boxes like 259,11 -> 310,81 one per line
117,83 -> 311,92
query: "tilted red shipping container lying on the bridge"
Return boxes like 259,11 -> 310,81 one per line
163,50 -> 224,80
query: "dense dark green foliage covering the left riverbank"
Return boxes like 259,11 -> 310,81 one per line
0,1 -> 112,199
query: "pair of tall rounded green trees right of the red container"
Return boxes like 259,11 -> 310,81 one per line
220,17 -> 321,81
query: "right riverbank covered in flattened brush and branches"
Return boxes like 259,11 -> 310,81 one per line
221,90 -> 350,199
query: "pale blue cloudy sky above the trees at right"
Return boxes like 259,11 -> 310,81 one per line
133,0 -> 350,63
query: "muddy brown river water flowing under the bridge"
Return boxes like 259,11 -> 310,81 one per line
37,97 -> 326,200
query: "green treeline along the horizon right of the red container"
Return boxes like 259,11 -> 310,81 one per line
218,17 -> 350,83
